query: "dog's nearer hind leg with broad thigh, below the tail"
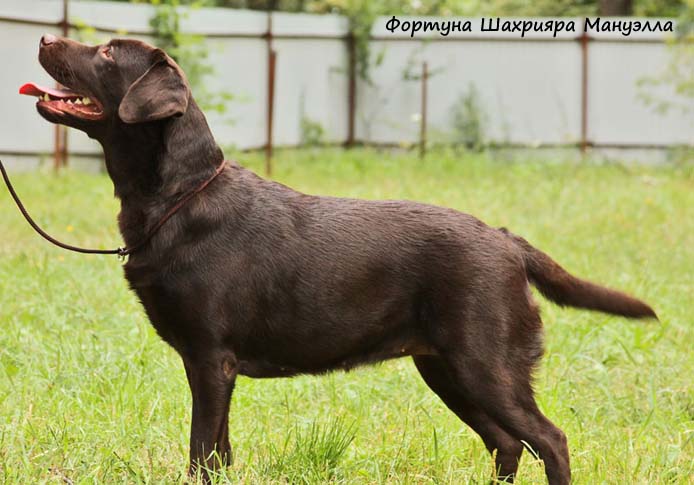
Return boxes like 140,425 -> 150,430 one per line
434,294 -> 571,485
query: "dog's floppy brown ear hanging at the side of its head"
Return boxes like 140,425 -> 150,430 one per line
118,52 -> 190,123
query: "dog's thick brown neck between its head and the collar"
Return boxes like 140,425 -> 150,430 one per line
99,98 -> 224,204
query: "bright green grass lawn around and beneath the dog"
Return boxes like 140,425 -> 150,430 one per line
0,150 -> 694,484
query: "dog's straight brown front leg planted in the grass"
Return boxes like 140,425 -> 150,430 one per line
183,350 -> 238,481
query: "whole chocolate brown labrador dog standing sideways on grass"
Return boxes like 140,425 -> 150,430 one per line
22,35 -> 655,484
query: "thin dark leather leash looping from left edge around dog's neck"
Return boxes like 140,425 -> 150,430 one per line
0,160 -> 226,259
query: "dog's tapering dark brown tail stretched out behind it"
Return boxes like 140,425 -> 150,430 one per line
501,228 -> 658,319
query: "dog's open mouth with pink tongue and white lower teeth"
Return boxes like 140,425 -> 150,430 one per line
19,83 -> 104,120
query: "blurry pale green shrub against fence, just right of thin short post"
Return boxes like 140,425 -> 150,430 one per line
451,84 -> 487,151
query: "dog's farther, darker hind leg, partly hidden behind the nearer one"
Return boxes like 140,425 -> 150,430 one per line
413,355 -> 523,483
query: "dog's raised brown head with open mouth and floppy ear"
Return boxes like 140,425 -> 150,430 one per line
20,34 -> 190,137
